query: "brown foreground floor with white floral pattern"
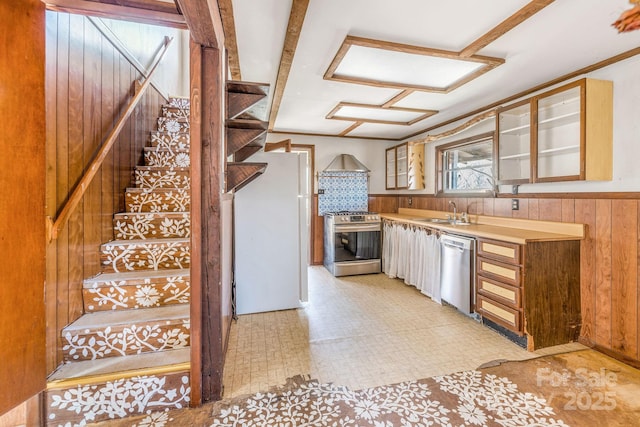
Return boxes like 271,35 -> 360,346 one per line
94,350 -> 640,427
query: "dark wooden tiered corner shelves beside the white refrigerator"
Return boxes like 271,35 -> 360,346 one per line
225,81 -> 269,191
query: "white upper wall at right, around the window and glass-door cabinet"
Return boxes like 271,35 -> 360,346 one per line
404,56 -> 640,194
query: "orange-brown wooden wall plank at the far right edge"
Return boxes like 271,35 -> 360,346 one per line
611,200 -> 638,358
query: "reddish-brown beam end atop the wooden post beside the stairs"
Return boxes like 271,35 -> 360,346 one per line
176,0 -> 224,49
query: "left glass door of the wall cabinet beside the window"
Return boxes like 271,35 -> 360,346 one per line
496,100 -> 531,184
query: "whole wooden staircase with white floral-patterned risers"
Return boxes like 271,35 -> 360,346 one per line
45,98 -> 191,426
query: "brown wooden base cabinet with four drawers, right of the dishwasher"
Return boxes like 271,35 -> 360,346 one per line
476,238 -> 581,351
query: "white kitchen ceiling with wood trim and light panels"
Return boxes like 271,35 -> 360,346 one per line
233,0 -> 640,139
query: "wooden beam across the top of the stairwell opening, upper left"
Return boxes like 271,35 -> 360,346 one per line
43,0 -> 187,29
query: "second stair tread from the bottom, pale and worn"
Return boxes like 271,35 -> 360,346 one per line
63,304 -> 190,336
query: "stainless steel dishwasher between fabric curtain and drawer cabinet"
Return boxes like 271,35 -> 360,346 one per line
440,234 -> 476,315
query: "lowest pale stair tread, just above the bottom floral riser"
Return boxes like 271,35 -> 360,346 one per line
47,347 -> 191,388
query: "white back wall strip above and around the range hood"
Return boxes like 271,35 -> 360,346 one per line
267,134 -> 398,194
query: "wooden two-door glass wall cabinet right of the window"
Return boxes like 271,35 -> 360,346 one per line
495,79 -> 613,184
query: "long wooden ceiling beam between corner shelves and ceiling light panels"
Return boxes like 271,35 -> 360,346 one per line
269,0 -> 309,131
